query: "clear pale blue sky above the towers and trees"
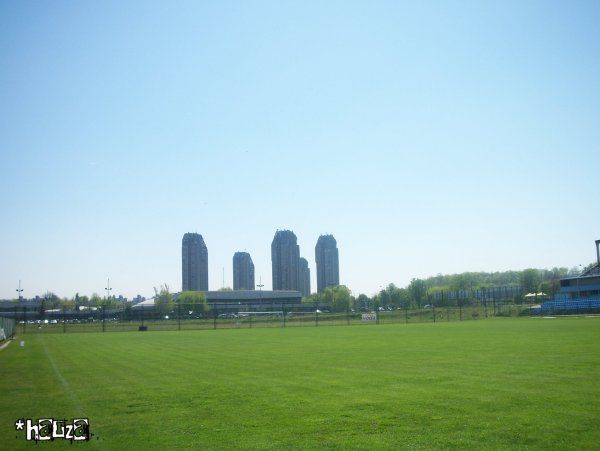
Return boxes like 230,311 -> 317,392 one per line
0,0 -> 600,298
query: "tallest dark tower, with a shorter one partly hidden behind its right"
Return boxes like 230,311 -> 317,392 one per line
271,230 -> 301,291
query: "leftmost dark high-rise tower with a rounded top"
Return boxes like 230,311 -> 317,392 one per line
181,233 -> 208,291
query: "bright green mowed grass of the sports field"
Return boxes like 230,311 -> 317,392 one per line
0,318 -> 600,449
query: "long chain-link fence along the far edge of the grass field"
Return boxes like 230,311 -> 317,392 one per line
0,302 -> 544,335
